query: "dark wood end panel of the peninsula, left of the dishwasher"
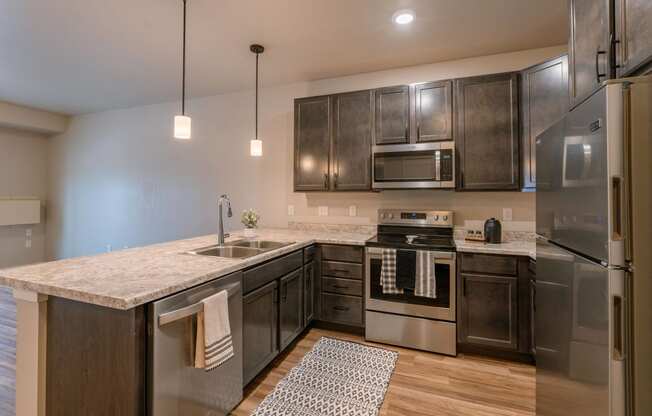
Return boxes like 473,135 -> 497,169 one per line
46,297 -> 147,416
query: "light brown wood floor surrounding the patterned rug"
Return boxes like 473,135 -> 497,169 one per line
233,328 -> 535,416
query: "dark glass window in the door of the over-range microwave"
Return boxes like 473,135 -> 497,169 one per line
374,151 -> 437,182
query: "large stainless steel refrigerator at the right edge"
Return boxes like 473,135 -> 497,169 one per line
535,77 -> 652,416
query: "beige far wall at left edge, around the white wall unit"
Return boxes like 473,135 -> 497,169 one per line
0,127 -> 47,269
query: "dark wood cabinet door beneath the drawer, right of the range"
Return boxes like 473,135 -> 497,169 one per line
458,273 -> 518,351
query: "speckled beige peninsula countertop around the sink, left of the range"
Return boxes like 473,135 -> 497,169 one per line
0,229 -> 372,310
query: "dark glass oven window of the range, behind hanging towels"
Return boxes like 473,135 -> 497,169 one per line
369,259 -> 451,308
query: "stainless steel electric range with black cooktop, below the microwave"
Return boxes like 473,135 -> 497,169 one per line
365,209 -> 457,355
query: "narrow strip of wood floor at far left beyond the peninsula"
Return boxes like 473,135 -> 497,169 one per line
0,287 -> 16,416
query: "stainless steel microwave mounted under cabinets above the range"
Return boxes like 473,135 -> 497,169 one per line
372,141 -> 455,189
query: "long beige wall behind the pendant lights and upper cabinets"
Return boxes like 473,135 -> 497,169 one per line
48,46 -> 565,258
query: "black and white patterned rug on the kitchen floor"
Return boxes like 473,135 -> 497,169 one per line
253,337 -> 398,416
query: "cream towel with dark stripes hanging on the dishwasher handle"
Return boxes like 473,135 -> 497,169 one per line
195,290 -> 234,371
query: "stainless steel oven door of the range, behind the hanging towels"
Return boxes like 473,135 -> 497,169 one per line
365,247 -> 457,322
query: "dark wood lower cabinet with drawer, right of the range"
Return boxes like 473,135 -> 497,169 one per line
457,253 -> 532,361
